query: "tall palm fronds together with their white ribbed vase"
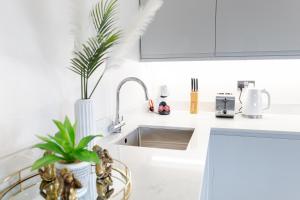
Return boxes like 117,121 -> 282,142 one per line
70,0 -> 120,141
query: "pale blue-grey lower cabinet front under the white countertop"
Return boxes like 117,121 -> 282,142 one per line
207,131 -> 300,200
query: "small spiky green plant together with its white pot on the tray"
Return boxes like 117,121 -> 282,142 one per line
32,117 -> 101,197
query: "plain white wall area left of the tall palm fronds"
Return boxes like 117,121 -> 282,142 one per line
0,0 -> 76,156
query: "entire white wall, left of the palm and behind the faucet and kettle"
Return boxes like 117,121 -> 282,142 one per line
0,0 -> 300,157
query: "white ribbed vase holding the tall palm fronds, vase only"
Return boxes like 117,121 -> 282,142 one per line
75,99 -> 95,142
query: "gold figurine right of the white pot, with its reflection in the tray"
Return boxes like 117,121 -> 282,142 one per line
93,145 -> 114,200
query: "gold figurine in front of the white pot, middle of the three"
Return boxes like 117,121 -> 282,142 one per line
60,168 -> 82,200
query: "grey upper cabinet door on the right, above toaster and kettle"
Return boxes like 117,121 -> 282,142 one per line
216,0 -> 300,56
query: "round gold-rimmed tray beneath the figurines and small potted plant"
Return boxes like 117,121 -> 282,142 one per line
0,159 -> 131,200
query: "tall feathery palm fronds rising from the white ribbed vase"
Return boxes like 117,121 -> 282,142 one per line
70,0 -> 120,99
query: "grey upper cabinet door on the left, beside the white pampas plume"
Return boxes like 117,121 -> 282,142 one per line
140,0 -> 216,60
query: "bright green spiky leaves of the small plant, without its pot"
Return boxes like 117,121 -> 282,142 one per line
32,117 -> 101,170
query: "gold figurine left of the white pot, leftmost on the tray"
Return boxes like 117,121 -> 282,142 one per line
38,151 -> 61,200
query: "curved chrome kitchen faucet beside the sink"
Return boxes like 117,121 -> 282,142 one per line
111,77 -> 149,133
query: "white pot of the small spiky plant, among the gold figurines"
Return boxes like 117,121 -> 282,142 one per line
55,162 -> 91,198
